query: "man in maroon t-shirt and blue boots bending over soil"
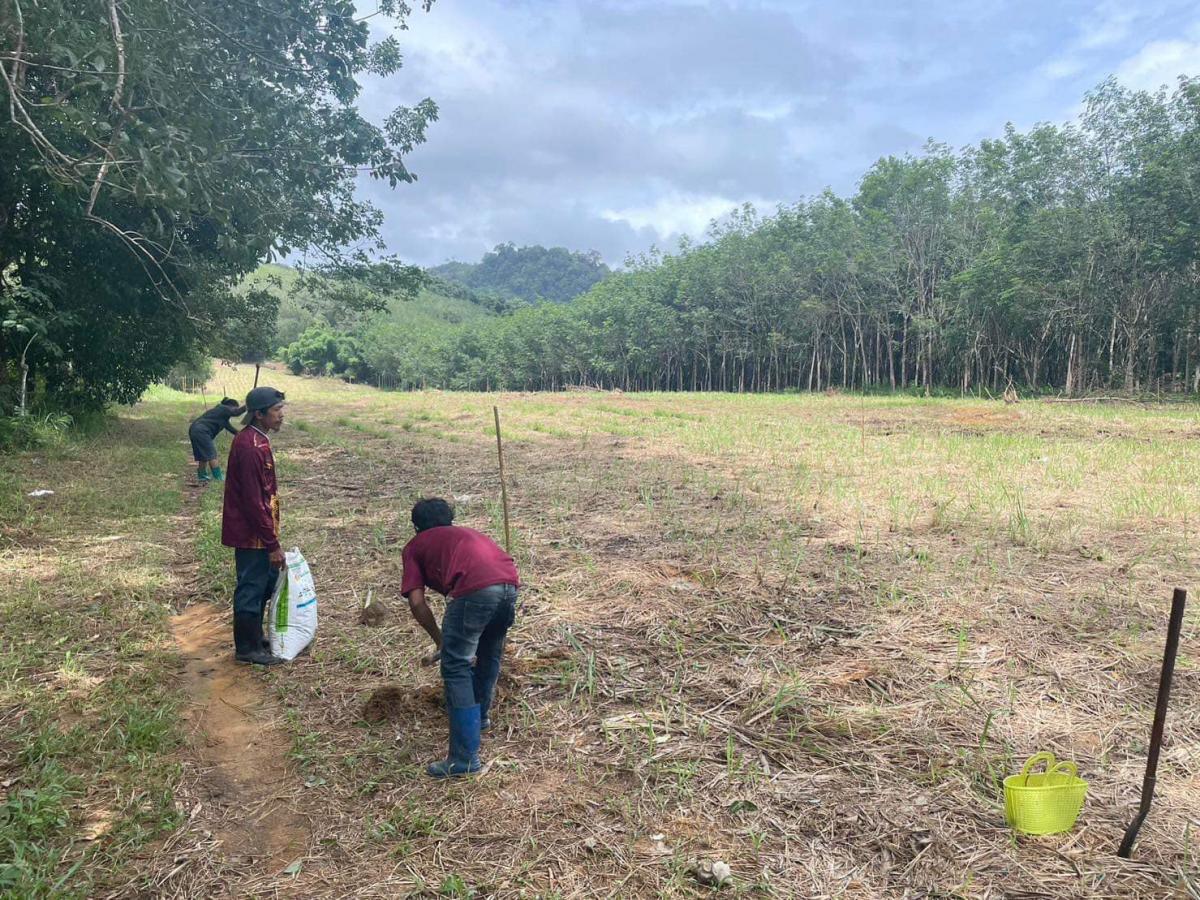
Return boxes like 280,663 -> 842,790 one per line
400,497 -> 521,778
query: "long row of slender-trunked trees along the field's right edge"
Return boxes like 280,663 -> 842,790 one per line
314,80 -> 1200,394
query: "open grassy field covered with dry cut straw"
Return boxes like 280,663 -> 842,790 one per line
0,368 -> 1200,898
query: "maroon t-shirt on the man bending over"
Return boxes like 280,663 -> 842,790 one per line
400,526 -> 521,596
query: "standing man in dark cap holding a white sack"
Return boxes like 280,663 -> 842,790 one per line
221,388 -> 284,666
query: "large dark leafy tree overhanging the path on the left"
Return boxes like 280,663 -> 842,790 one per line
0,0 -> 437,404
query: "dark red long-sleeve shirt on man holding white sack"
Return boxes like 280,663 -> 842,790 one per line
221,426 -> 280,551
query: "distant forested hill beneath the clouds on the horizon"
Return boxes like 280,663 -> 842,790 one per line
426,244 -> 611,304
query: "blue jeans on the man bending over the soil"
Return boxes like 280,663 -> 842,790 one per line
442,584 -> 517,719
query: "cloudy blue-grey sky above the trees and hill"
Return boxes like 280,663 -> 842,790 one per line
359,0 -> 1200,265
